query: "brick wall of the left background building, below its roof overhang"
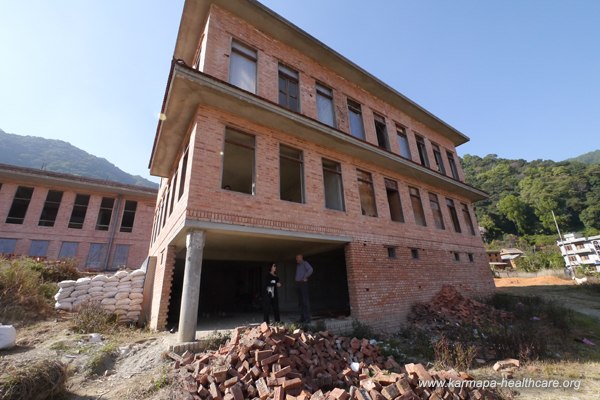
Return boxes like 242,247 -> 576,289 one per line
0,180 -> 154,269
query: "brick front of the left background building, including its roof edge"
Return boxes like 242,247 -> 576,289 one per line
0,166 -> 156,270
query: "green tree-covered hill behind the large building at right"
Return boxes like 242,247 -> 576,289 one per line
462,154 -> 600,239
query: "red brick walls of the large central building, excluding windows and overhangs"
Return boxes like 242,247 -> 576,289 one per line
145,1 -> 494,331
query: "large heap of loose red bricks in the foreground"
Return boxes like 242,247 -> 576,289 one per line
169,324 -> 496,400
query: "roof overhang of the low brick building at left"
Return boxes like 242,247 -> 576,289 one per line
0,167 -> 158,200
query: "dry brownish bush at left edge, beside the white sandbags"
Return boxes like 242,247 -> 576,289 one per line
0,259 -> 57,323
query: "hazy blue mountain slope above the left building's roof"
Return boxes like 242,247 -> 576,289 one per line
0,129 -> 158,187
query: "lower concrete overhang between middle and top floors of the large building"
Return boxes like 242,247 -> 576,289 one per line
150,62 -> 487,201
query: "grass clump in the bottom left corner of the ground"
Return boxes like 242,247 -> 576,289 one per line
0,360 -> 67,400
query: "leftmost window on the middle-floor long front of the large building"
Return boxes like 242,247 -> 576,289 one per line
221,129 -> 255,194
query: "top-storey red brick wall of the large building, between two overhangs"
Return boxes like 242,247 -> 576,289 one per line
200,5 -> 464,180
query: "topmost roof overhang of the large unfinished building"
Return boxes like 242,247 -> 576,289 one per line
173,0 -> 469,146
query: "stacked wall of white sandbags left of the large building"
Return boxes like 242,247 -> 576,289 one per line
54,269 -> 146,322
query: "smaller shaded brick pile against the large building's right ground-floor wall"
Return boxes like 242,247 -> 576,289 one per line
408,285 -> 513,330
